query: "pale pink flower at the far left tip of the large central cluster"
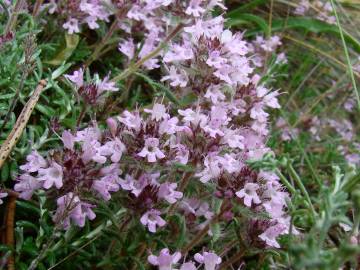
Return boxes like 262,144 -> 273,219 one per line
14,173 -> 43,200
